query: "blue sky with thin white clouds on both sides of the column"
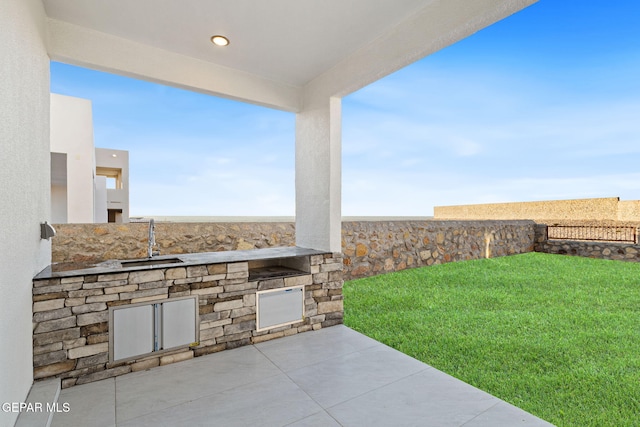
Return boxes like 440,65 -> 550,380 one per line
51,0 -> 640,216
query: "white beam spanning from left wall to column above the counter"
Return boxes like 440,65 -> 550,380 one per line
48,18 -> 301,112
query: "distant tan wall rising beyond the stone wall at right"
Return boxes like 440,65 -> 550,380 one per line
433,197 -> 628,221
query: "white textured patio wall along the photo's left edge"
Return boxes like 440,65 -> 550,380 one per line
0,0 -> 51,427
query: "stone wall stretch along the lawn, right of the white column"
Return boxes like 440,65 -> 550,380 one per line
342,221 -> 535,280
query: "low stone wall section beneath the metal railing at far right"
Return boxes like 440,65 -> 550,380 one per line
534,224 -> 640,262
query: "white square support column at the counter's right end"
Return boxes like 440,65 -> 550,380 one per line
296,97 -> 342,252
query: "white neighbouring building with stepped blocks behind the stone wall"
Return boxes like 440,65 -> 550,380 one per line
50,93 -> 129,224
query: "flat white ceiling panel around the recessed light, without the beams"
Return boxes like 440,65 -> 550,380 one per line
44,0 -> 432,86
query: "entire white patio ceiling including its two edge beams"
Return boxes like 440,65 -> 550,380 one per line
42,0 -> 535,111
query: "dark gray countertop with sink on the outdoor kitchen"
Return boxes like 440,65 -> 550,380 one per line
33,246 -> 328,280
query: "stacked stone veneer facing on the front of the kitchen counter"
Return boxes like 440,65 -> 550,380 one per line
33,254 -> 343,387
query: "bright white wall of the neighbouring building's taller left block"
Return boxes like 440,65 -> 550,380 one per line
51,93 -> 95,223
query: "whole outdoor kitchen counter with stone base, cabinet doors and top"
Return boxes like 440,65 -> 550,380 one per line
32,247 -> 344,388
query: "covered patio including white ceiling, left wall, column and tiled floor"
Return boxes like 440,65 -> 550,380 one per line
0,0 -> 538,426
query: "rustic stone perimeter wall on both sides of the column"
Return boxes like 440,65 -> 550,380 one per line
52,220 -> 534,280
